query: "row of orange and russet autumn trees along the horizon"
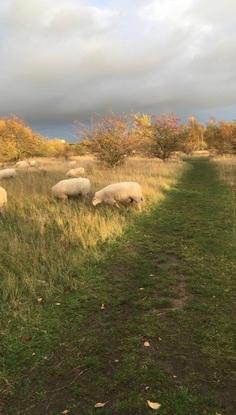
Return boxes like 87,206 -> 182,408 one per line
0,114 -> 236,166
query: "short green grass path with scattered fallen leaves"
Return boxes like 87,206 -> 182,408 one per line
0,160 -> 236,415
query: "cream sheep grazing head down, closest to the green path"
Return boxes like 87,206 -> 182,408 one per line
92,182 -> 144,208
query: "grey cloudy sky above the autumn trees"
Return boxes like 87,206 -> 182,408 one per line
0,0 -> 236,137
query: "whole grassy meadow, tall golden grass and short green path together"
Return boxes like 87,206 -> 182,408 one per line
0,157 -> 236,415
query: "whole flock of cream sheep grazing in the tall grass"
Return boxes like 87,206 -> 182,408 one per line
0,160 -> 144,212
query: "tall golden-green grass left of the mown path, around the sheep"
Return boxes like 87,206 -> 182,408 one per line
0,158 -> 183,318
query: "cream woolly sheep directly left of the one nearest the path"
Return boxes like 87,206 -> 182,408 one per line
52,177 -> 91,199
